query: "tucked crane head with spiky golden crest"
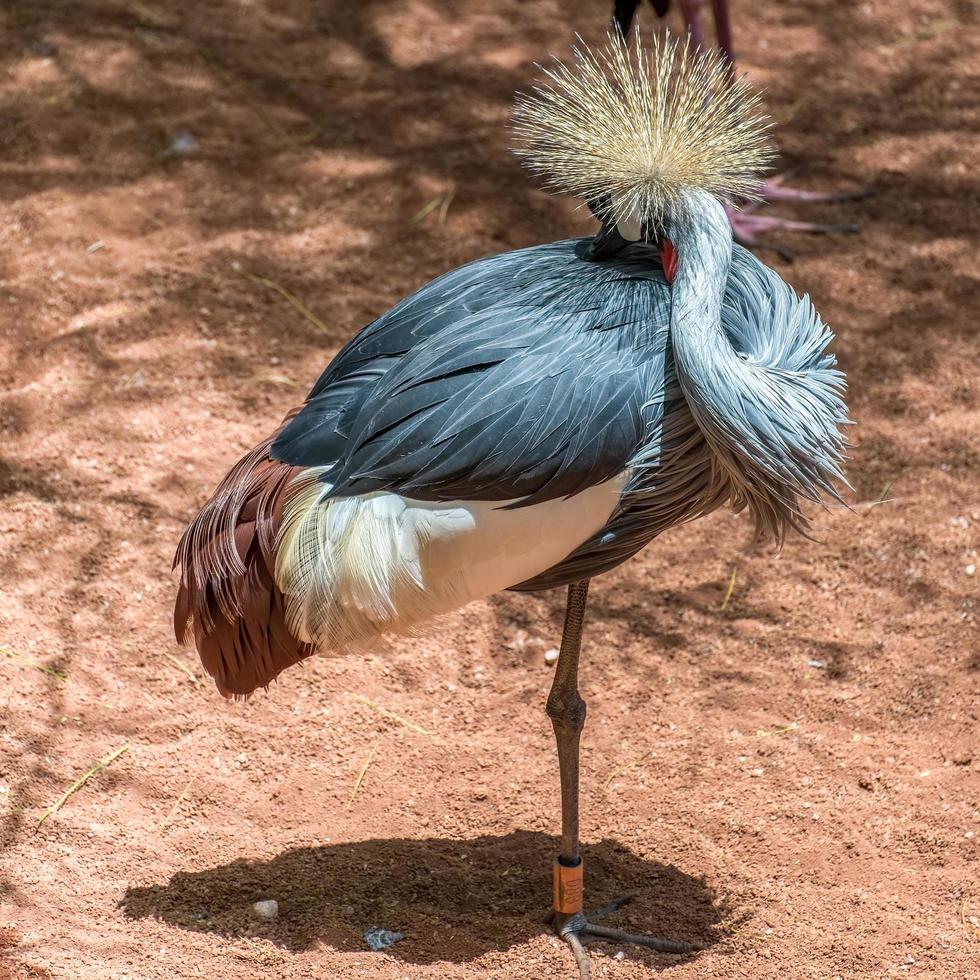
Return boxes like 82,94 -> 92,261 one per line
514,33 -> 775,280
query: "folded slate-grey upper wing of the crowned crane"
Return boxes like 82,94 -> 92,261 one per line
273,242 -> 669,506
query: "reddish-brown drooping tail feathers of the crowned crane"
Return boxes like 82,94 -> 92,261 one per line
174,418 -> 314,697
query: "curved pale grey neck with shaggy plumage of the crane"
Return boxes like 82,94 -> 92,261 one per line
669,190 -> 845,542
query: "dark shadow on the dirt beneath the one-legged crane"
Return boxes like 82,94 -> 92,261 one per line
122,831 -> 733,967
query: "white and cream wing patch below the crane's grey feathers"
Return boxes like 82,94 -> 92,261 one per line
276,471 -> 626,653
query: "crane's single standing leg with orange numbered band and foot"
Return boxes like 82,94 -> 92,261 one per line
546,579 -> 700,980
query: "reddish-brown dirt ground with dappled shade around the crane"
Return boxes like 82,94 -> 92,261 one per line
0,0 -> 980,980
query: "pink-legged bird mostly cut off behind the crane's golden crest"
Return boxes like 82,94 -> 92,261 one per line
612,0 -> 873,255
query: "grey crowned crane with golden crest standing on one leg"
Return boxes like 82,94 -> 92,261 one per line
174,33 -> 848,980
